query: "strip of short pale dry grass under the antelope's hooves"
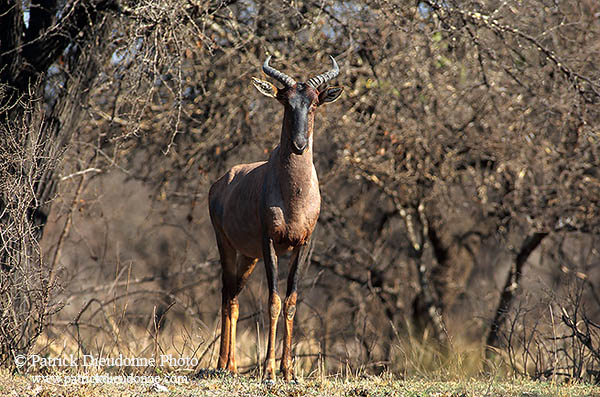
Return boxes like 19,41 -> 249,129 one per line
0,371 -> 600,397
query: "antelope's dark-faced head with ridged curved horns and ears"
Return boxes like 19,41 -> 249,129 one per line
252,56 -> 343,155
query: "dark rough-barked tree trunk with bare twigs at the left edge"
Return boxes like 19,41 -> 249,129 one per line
0,1 -> 112,363
